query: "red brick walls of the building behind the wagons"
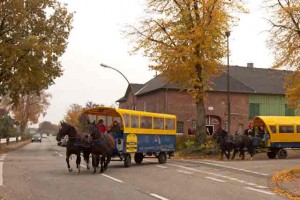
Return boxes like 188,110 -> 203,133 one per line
120,89 -> 251,133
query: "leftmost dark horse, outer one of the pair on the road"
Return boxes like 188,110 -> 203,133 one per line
56,122 -> 90,172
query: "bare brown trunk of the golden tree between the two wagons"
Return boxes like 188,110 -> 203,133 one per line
195,97 -> 207,145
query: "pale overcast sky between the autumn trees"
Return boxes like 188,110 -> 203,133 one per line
39,0 -> 272,123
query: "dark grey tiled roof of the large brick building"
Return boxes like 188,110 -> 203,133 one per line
118,66 -> 289,101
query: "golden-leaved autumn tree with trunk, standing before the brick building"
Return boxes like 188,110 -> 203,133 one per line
128,0 -> 246,144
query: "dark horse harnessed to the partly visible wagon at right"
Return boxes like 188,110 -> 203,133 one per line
213,129 -> 254,160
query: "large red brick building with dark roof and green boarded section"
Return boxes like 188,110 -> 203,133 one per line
117,64 -> 295,133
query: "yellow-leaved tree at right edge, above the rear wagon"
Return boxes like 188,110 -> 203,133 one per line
266,0 -> 300,108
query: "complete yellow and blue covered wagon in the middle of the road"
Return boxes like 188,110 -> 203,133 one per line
84,106 -> 176,167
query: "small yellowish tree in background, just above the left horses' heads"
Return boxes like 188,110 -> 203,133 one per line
64,104 -> 83,130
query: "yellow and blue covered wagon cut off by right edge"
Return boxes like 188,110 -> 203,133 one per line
253,116 -> 300,159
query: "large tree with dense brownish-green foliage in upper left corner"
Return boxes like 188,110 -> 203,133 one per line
0,0 -> 73,102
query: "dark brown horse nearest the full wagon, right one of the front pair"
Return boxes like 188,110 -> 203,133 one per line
90,124 -> 115,173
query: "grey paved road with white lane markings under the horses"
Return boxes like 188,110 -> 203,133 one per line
0,138 -> 300,200
